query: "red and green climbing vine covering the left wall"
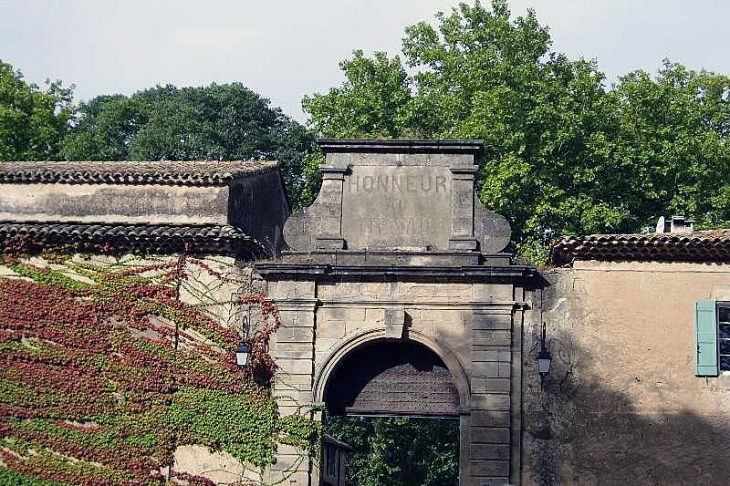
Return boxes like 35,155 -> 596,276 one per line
0,240 -> 317,486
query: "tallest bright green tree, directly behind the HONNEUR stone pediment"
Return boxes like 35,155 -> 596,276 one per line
303,0 -> 627,258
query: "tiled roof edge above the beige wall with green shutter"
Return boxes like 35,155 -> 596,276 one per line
550,230 -> 730,265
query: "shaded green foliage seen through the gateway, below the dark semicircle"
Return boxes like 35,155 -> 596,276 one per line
325,416 -> 459,486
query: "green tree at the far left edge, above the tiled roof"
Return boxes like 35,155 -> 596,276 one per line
0,60 -> 73,160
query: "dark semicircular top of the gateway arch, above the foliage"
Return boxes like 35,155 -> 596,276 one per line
323,340 -> 460,417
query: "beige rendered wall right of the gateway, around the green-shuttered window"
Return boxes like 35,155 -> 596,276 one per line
522,262 -> 730,485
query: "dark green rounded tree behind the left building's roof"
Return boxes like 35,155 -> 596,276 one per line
63,83 -> 314,207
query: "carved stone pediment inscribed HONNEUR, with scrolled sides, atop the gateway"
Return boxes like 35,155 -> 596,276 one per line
284,140 -> 511,253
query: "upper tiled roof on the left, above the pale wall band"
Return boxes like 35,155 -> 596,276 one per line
0,160 -> 278,186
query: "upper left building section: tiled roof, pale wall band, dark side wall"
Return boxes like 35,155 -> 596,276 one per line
0,161 -> 290,256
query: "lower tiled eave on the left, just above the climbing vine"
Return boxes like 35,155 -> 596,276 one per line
0,221 -> 266,258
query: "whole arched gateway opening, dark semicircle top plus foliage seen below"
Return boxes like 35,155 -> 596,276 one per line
324,341 -> 459,486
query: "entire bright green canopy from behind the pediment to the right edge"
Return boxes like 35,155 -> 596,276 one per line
303,0 -> 730,256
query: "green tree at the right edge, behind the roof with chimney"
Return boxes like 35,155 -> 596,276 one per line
612,60 -> 730,227
